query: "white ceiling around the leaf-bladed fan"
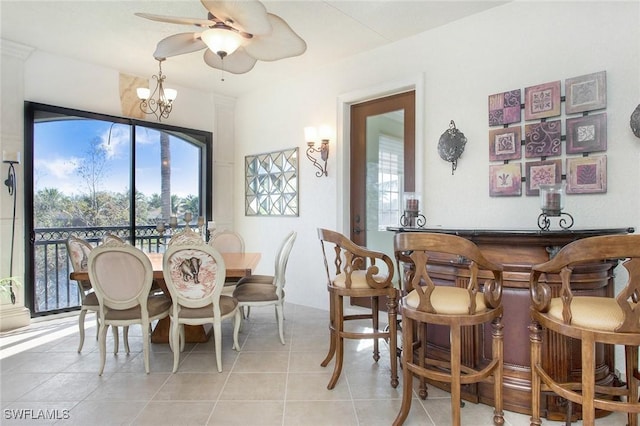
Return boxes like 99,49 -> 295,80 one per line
0,0 -> 507,96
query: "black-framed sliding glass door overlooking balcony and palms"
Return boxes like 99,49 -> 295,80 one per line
25,103 -> 212,315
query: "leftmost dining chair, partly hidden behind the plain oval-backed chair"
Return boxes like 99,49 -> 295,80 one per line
66,235 -> 129,353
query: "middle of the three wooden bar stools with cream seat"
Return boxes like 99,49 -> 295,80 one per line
393,232 -> 504,426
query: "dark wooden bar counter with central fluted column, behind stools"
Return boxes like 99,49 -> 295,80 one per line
388,228 -> 634,420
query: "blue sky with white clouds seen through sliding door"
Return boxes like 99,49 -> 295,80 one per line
34,119 -> 200,197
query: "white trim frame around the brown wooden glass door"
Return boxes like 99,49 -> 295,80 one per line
336,73 -> 425,237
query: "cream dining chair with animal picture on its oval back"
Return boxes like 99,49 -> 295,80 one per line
162,231 -> 241,373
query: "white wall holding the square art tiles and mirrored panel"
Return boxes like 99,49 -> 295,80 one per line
235,1 -> 640,307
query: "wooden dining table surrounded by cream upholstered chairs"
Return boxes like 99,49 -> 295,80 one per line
69,253 -> 261,343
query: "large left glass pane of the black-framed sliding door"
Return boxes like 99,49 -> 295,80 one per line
33,113 -> 131,313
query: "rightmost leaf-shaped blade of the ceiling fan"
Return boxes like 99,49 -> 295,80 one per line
244,13 -> 307,61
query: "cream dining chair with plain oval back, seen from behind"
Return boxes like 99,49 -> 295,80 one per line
88,240 -> 171,375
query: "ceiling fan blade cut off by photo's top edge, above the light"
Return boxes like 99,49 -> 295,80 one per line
200,0 -> 271,35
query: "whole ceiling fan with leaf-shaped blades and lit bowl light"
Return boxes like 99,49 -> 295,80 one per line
136,0 -> 307,74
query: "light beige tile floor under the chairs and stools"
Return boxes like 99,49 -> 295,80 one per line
0,304 -> 626,426
